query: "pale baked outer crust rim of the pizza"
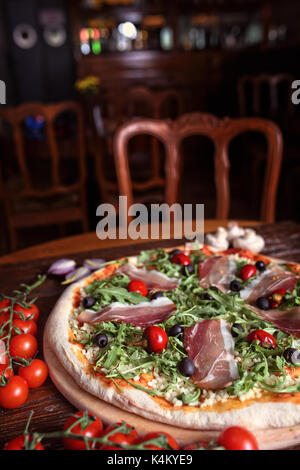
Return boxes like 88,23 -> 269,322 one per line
44,252 -> 300,430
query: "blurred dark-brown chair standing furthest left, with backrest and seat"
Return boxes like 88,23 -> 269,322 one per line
0,101 -> 88,250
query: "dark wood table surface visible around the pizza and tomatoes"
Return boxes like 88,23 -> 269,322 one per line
0,222 -> 300,449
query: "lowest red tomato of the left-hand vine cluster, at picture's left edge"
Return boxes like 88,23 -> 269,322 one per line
0,375 -> 28,410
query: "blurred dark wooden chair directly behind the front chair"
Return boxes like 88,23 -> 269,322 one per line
94,86 -> 184,207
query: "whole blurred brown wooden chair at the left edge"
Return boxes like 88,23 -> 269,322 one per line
0,102 -> 88,250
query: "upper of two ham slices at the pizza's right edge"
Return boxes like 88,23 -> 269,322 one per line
240,266 -> 299,303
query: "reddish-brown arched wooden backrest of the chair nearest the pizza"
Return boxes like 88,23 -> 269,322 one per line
114,113 -> 282,222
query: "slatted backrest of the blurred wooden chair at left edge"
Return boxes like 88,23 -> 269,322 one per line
0,101 -> 86,199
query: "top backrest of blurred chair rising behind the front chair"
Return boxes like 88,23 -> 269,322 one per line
109,86 -> 183,125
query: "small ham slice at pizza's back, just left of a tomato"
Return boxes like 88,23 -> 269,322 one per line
199,255 -> 236,292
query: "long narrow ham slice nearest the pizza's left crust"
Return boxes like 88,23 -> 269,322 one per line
77,297 -> 176,326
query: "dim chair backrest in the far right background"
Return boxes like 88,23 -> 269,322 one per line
238,73 -> 294,118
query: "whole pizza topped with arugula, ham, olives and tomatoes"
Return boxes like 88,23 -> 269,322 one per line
45,243 -> 300,430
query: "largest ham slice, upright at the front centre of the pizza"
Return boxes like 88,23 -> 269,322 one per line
184,320 -> 239,390
